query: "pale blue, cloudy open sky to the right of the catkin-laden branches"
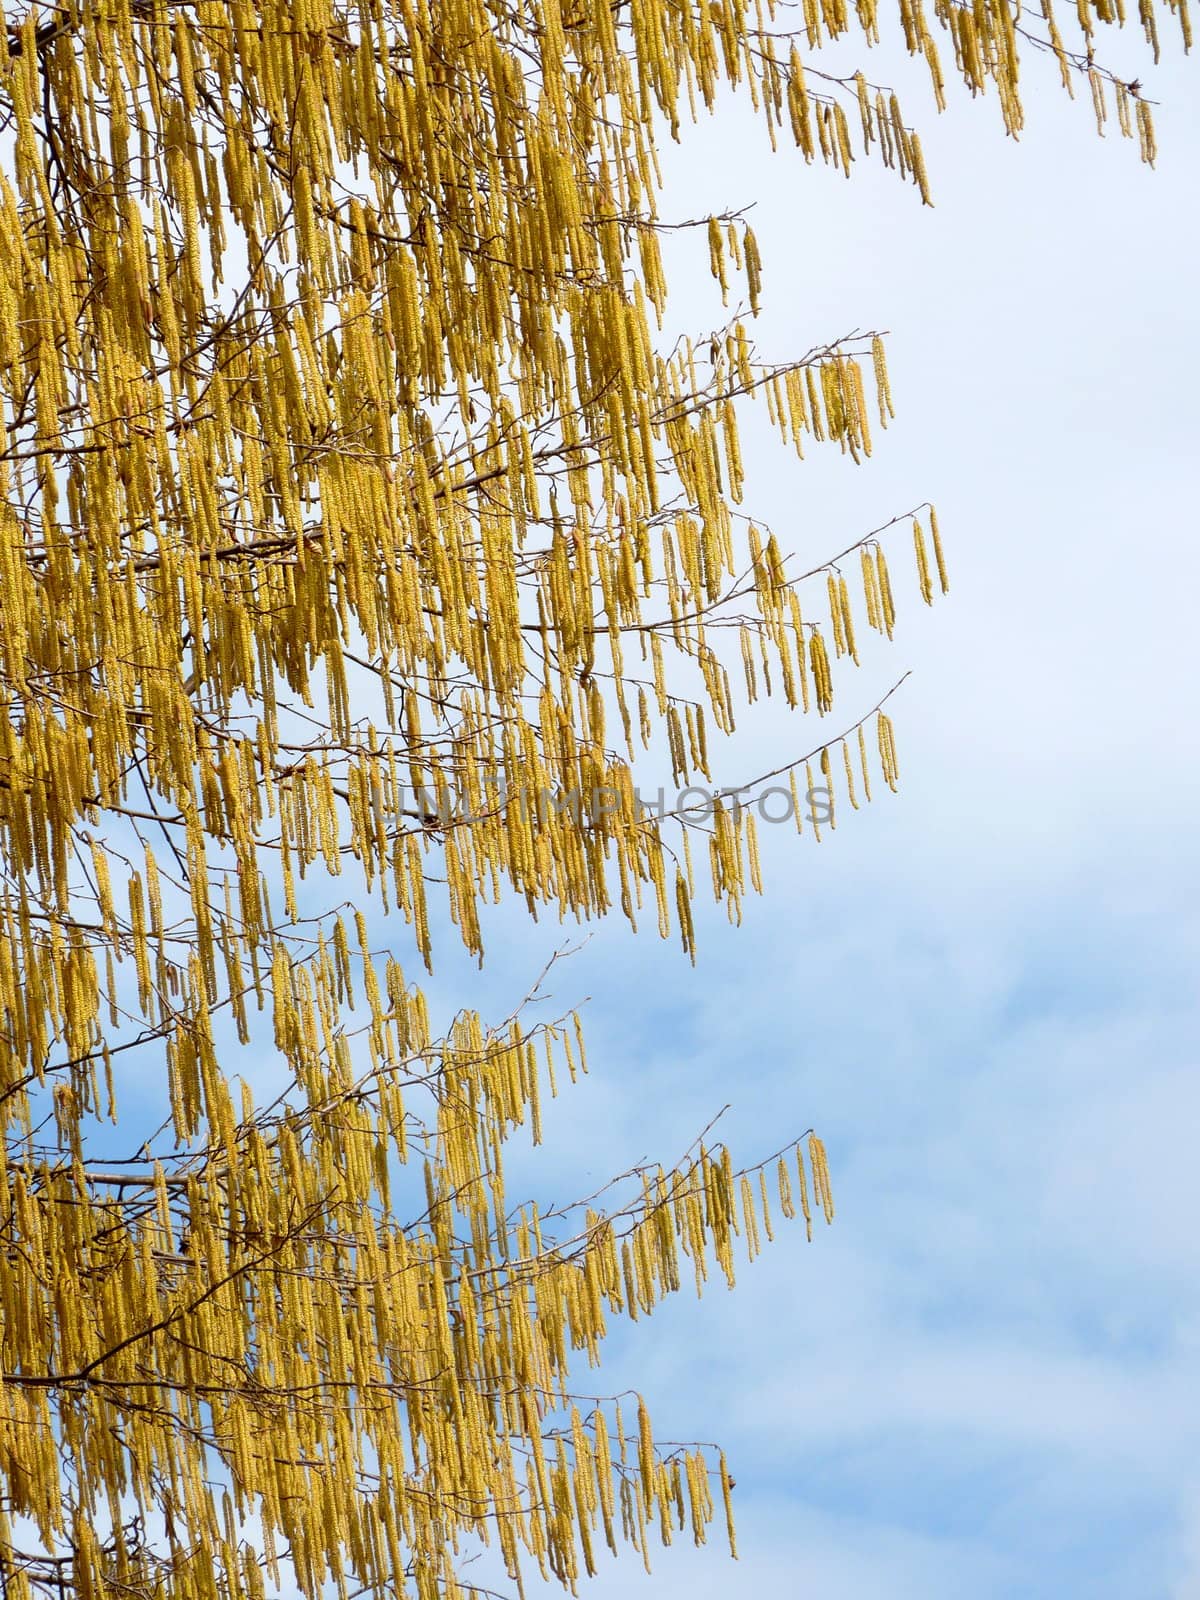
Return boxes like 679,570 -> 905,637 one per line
404,25 -> 1200,1600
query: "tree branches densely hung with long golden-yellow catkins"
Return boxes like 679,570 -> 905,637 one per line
0,0 -> 1189,1600
